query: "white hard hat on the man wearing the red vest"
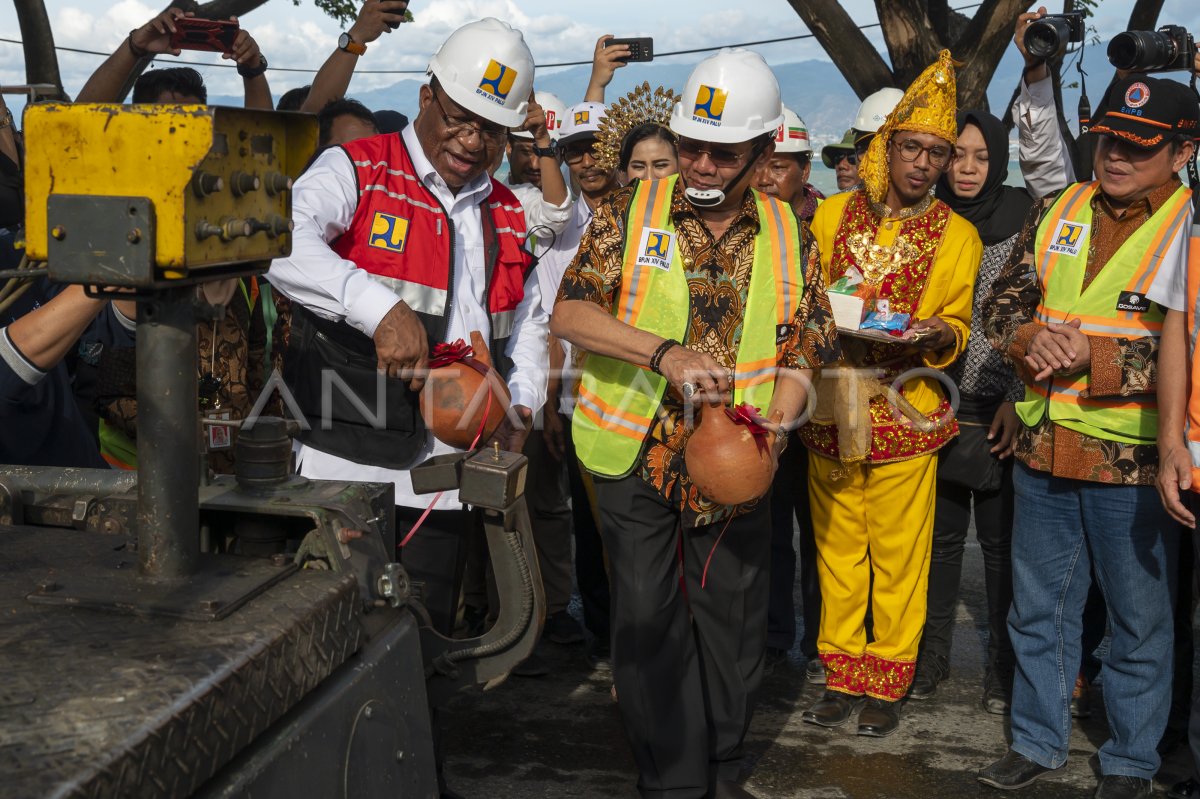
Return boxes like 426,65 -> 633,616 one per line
430,17 -> 533,127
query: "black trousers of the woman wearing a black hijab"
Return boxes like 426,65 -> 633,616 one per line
920,458 -> 1014,675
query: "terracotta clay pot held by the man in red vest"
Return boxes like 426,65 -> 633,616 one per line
421,330 -> 510,450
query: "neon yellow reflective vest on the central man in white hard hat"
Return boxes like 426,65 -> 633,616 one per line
571,175 -> 804,476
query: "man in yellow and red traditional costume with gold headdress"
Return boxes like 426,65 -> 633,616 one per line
799,50 -> 983,737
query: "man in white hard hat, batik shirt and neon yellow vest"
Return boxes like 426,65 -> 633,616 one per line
552,50 -> 836,799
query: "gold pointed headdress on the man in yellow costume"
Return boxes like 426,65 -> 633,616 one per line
858,50 -> 959,203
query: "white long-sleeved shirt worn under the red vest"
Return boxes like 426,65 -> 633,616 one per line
268,125 -> 550,510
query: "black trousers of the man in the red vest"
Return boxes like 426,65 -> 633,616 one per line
396,505 -> 479,636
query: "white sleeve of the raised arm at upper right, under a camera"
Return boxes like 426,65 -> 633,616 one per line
1013,78 -> 1075,198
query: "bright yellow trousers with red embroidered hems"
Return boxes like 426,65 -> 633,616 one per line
809,452 -> 937,701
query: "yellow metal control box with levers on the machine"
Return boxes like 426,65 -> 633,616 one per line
24,103 -> 317,280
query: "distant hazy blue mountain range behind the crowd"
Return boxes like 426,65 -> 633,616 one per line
211,46 -> 1166,145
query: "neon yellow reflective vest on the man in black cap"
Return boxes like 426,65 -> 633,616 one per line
1016,182 -> 1192,444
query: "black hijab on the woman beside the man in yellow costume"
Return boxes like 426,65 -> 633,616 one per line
937,110 -> 1033,247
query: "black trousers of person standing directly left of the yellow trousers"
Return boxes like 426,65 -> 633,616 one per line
767,433 -> 821,660
